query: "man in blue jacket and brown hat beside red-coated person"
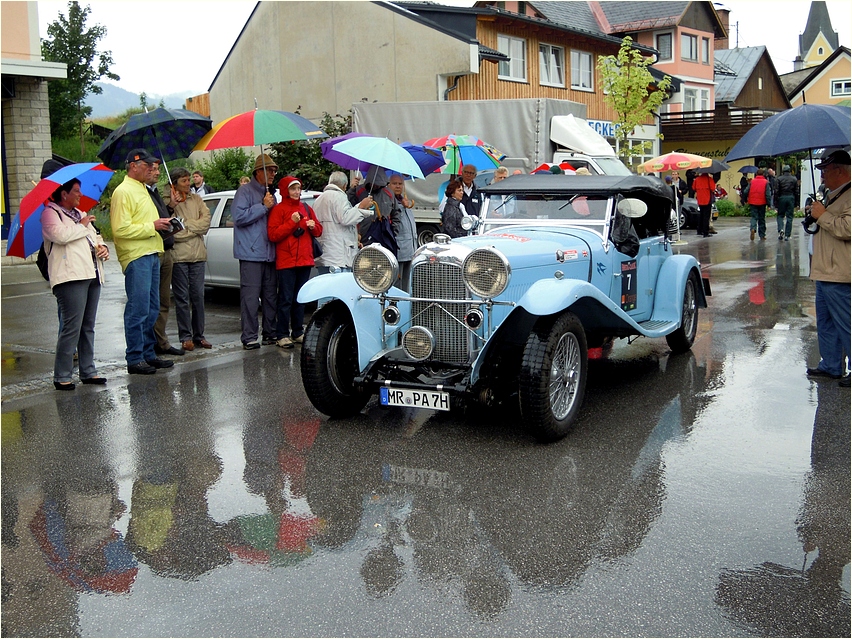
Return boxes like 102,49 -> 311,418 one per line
231,154 -> 278,351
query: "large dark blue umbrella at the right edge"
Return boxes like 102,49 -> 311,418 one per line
725,104 -> 852,162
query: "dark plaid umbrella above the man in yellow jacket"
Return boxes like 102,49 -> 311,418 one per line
98,108 -> 213,169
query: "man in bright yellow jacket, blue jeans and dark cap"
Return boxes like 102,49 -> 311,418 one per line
109,149 -> 174,375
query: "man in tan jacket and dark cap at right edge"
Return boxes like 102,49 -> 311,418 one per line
808,149 -> 852,387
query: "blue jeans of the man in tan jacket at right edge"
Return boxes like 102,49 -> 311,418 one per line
816,281 -> 852,375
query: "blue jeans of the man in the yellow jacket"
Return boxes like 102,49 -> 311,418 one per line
124,253 -> 160,366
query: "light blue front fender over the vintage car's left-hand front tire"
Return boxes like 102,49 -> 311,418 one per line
297,273 -> 411,372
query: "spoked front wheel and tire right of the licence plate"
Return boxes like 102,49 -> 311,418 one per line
518,313 -> 588,442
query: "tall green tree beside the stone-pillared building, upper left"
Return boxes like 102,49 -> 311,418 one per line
41,1 -> 120,148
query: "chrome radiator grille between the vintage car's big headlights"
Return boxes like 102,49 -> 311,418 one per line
411,262 -> 469,364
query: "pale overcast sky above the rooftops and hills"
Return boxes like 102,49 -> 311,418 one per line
38,0 -> 852,95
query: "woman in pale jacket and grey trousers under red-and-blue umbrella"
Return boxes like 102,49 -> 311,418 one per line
41,179 -> 109,391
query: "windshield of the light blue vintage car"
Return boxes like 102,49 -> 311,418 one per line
482,193 -> 609,232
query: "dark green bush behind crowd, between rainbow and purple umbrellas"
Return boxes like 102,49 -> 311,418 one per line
272,111 -> 352,191
